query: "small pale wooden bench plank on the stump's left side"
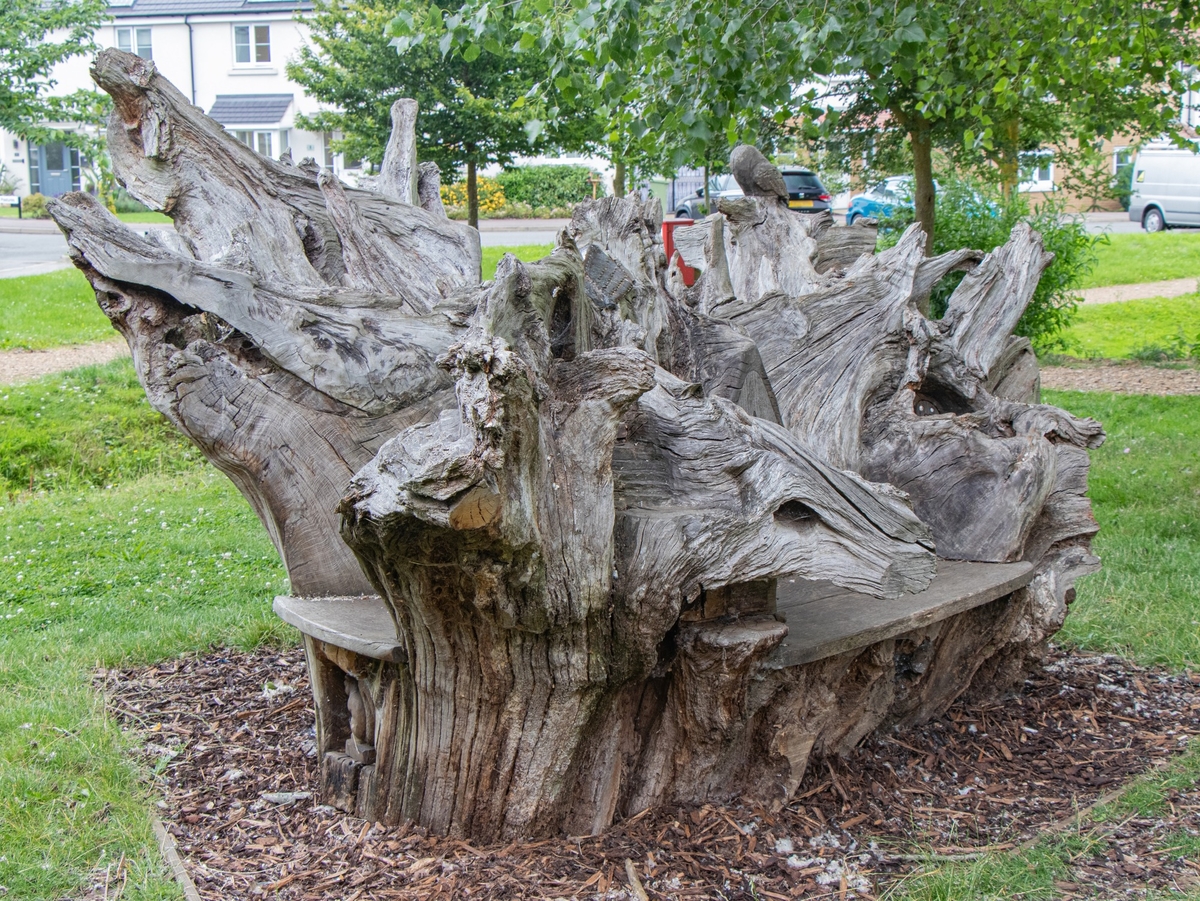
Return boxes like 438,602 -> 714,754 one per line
272,594 -> 407,663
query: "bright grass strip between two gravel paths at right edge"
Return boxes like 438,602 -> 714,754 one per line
1061,294 -> 1200,360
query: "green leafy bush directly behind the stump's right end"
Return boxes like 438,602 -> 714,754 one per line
880,179 -> 1108,352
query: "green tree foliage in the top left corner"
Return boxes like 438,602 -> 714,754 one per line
0,0 -> 108,155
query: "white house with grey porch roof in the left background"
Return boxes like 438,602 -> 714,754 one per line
0,0 -> 343,196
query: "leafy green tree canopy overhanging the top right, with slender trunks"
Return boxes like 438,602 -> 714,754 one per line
417,0 -> 1196,246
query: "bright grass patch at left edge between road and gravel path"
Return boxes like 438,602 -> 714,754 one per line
0,268 -> 116,350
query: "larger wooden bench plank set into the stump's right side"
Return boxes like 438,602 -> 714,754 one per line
770,560 -> 1033,668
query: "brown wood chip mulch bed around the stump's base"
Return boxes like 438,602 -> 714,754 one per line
97,650 -> 1200,901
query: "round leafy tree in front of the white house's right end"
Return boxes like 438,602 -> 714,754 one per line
288,0 -> 600,226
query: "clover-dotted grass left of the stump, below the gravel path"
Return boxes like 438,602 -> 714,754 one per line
0,360 -> 284,901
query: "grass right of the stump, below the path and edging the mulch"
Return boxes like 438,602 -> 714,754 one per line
886,391 -> 1200,901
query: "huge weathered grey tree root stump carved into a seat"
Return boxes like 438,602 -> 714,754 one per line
52,50 -> 1102,839
